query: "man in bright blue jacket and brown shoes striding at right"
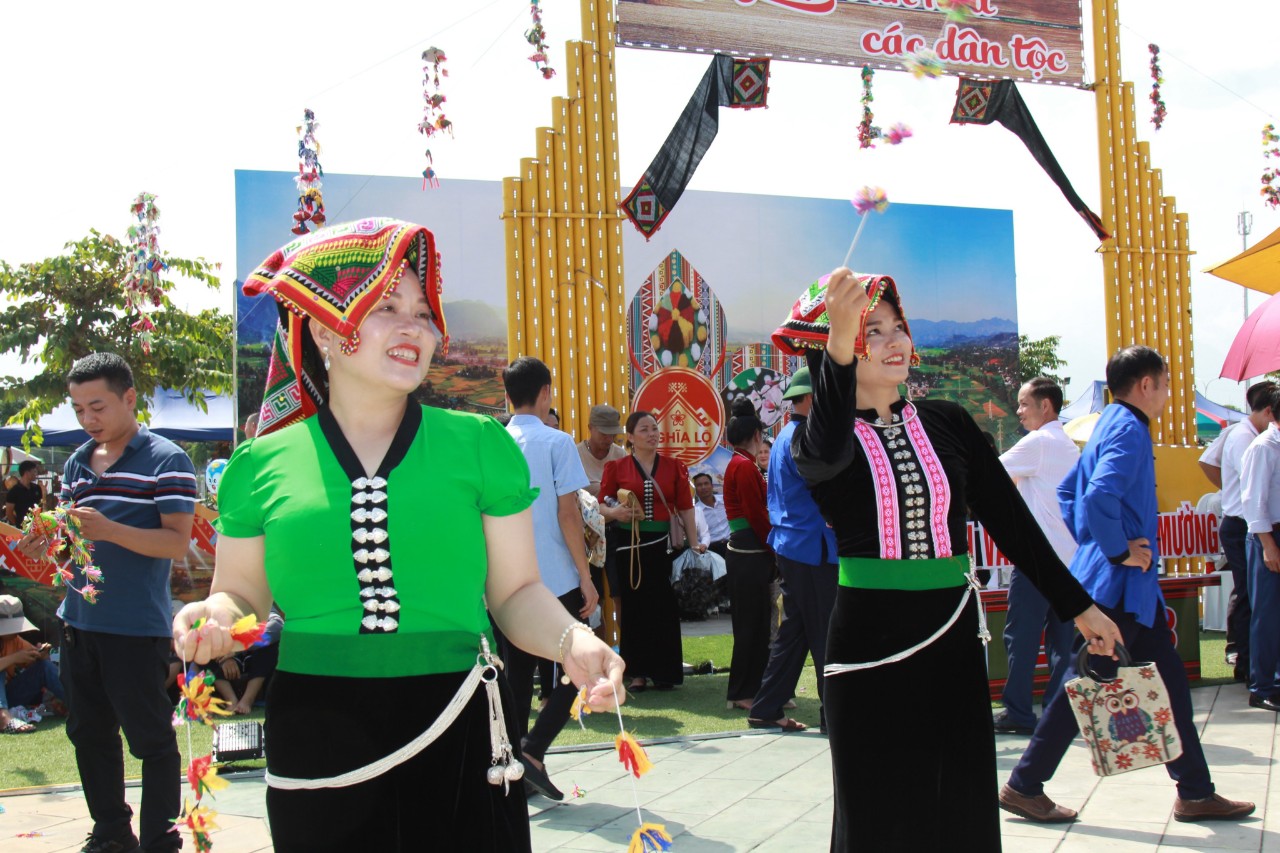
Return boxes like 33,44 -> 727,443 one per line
1000,346 -> 1253,824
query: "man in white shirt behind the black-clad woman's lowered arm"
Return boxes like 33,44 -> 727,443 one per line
995,377 -> 1080,734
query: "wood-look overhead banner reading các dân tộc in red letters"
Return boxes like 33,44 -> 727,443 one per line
617,0 -> 1084,86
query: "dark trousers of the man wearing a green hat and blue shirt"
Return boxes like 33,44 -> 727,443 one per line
751,555 -> 838,720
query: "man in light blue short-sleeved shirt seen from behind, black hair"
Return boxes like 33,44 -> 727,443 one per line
502,356 -> 599,800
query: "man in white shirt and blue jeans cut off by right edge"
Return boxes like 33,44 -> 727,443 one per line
1239,387 -> 1280,712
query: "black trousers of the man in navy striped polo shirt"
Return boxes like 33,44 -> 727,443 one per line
60,625 -> 182,853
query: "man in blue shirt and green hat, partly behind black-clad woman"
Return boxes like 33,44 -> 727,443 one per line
748,368 -> 840,731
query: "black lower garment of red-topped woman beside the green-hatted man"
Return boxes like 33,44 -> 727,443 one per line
724,528 -> 777,702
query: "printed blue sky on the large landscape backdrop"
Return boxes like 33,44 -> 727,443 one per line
236,170 -> 1018,341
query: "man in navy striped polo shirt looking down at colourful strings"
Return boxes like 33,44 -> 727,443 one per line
19,352 -> 196,853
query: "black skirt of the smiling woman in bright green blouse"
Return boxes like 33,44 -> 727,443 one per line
266,666 -> 530,853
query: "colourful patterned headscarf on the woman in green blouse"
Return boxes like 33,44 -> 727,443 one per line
243,218 -> 449,435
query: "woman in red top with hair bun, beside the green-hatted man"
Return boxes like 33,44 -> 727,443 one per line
724,398 -> 777,712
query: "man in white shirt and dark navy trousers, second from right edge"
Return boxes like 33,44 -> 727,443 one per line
1201,382 -> 1276,681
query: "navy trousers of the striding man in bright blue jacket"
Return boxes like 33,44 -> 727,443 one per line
1009,602 -> 1213,799
